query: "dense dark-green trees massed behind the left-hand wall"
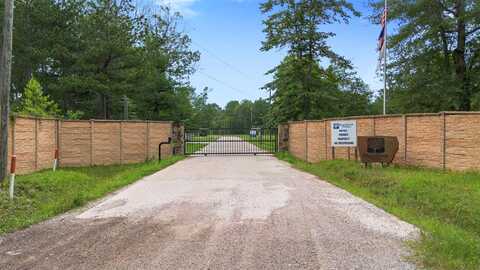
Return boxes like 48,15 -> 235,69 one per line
12,0 -> 200,120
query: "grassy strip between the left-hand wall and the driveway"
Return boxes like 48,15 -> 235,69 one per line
0,156 -> 183,235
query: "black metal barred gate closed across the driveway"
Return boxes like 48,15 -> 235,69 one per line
184,128 -> 278,155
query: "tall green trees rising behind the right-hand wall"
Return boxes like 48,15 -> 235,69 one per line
261,0 -> 480,121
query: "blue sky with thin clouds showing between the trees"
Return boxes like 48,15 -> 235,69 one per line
140,0 -> 382,106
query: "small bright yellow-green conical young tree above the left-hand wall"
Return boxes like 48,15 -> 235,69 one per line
14,78 -> 60,117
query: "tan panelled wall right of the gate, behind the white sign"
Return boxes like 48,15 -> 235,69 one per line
288,112 -> 480,170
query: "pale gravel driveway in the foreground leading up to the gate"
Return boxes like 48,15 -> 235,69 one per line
0,156 -> 417,270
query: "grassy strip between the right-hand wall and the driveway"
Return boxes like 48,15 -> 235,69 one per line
277,153 -> 480,270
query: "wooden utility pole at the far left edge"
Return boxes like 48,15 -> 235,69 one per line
0,0 -> 14,183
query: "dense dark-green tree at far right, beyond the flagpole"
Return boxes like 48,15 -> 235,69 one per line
372,0 -> 480,112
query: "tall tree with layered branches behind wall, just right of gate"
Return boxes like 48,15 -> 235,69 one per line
261,0 -> 366,121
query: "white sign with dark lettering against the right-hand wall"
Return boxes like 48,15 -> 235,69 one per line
330,120 -> 357,147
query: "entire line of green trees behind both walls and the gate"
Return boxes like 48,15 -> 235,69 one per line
0,0 -> 480,127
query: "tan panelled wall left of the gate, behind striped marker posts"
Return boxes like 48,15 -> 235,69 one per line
5,117 -> 173,174
